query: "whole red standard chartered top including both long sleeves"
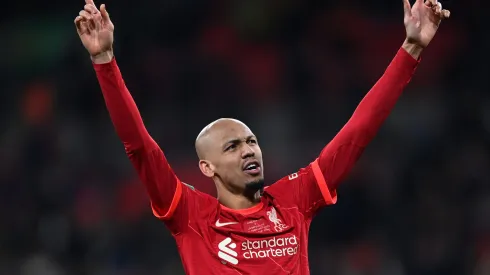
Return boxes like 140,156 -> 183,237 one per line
94,46 -> 418,275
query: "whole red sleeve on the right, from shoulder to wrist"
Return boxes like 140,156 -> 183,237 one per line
266,48 -> 420,219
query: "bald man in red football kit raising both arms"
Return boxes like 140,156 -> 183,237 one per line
75,0 -> 449,275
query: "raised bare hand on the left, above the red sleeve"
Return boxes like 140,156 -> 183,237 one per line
75,0 -> 114,63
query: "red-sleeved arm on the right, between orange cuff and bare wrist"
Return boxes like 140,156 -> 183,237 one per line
318,43 -> 420,190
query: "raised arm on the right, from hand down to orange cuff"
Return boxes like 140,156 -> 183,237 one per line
318,0 -> 449,191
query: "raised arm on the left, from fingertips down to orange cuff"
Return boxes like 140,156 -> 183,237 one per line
75,0 -> 182,219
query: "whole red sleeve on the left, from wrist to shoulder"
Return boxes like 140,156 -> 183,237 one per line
93,59 -> 211,233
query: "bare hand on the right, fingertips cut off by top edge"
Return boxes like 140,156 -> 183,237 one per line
403,0 -> 450,48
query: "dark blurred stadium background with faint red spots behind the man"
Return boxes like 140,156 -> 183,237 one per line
0,0 -> 490,275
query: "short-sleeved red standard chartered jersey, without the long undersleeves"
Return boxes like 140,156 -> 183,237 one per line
161,161 -> 337,274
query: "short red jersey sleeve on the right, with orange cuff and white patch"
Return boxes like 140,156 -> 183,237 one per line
265,159 -> 337,218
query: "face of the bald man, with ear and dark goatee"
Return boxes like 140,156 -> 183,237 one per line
200,120 -> 264,193
